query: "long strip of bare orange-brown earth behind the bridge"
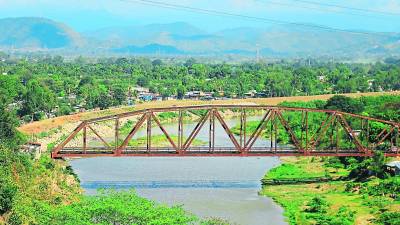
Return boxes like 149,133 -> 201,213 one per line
19,91 -> 400,135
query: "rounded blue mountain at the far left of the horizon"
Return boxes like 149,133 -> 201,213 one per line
0,17 -> 84,49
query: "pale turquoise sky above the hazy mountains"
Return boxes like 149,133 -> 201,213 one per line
0,0 -> 400,32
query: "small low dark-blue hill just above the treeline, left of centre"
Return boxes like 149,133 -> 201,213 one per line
113,44 -> 184,55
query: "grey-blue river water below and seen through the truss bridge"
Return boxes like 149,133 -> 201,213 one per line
71,117 -> 287,225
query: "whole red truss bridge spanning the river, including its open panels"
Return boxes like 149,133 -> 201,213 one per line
52,105 -> 400,158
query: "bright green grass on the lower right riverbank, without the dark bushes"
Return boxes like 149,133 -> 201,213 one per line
260,157 -> 400,224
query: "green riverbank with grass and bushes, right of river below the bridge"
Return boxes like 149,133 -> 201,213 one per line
260,157 -> 400,225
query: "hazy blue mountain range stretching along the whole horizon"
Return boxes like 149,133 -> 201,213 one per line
0,17 -> 400,57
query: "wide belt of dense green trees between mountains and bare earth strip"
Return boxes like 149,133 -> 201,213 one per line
0,56 -> 400,121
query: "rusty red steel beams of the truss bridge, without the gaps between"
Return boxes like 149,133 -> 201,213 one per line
52,105 -> 400,157
